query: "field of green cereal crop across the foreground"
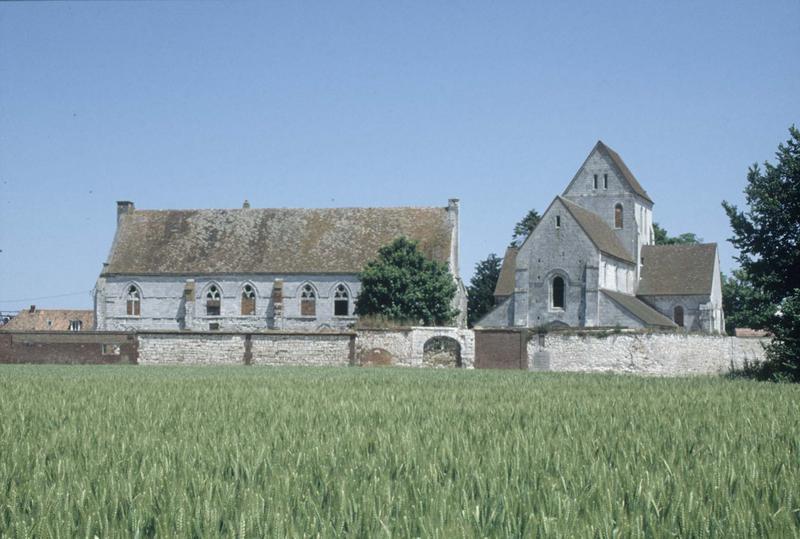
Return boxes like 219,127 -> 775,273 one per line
0,366 -> 800,538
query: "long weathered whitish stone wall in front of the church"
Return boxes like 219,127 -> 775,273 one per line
528,333 -> 767,376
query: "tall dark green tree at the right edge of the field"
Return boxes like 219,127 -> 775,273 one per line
722,126 -> 800,381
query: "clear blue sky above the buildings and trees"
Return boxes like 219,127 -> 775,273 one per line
0,0 -> 800,310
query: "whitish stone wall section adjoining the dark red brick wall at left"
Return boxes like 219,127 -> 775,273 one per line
138,333 -> 245,365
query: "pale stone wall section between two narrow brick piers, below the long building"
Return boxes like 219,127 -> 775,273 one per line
251,333 -> 353,366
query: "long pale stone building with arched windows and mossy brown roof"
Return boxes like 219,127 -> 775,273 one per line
95,199 -> 466,331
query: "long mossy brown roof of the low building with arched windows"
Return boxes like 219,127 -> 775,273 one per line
103,207 -> 452,275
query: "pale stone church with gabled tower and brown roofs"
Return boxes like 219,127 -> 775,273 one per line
476,141 -> 725,333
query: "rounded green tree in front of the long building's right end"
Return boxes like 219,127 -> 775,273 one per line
355,237 -> 458,325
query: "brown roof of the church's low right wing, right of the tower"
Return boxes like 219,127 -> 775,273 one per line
636,243 -> 717,296
